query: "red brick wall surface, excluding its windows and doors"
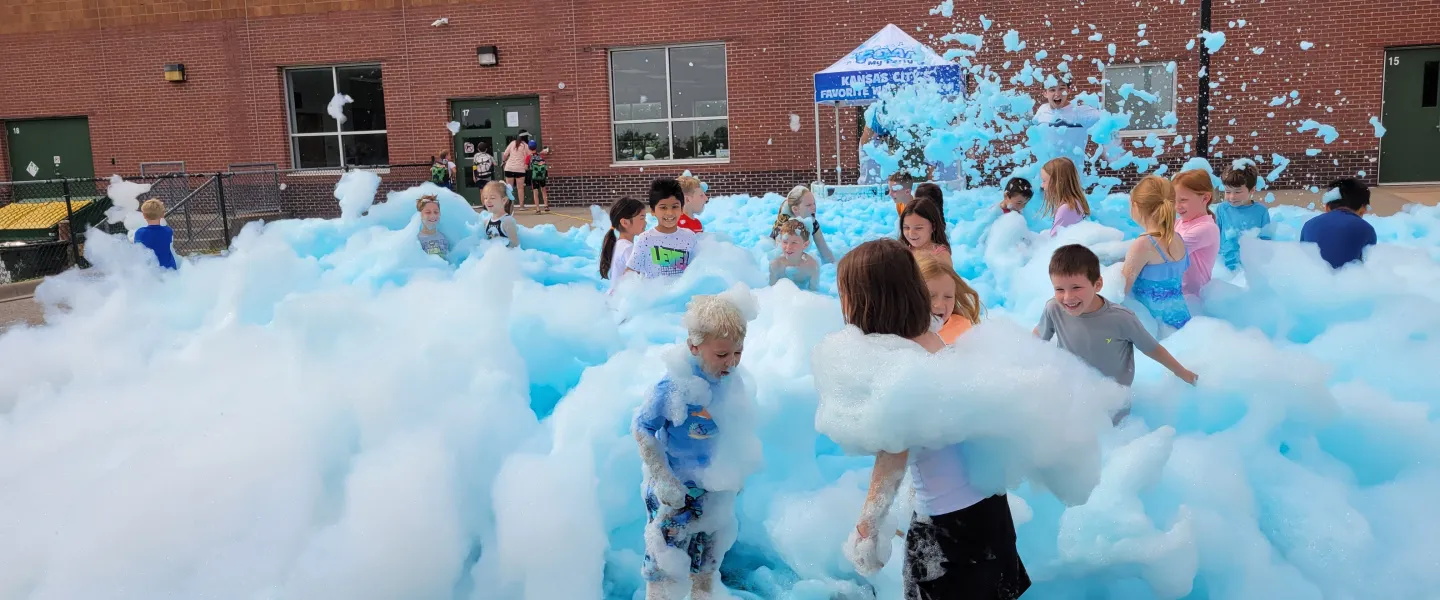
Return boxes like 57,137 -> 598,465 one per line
0,0 -> 1440,210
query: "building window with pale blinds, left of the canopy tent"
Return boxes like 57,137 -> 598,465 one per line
611,45 -> 730,163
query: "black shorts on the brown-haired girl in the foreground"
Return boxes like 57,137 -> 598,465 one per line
904,494 -> 1030,600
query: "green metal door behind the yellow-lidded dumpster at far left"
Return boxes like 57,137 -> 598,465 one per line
4,117 -> 95,200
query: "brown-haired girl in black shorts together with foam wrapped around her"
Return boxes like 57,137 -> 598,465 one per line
812,240 -> 1123,599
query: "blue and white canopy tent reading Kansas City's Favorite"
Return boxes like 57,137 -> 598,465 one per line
815,24 -> 963,186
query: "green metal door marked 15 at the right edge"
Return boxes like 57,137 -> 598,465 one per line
1380,47 -> 1440,183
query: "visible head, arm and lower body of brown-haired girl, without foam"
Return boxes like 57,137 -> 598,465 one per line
837,240 -> 1030,600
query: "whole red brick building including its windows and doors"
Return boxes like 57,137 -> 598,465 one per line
0,0 -> 1440,214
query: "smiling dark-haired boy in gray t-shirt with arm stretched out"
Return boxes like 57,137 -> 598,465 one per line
1035,243 -> 1197,423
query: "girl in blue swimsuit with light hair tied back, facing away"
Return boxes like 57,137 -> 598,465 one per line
1120,176 -> 1189,329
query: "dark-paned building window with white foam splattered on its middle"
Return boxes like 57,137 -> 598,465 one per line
285,65 -> 390,168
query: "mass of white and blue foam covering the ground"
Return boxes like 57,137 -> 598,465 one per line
0,168 -> 1440,600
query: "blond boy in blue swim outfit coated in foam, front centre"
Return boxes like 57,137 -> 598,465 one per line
632,288 -> 759,600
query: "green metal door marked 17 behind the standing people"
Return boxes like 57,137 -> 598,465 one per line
451,98 -> 543,204
